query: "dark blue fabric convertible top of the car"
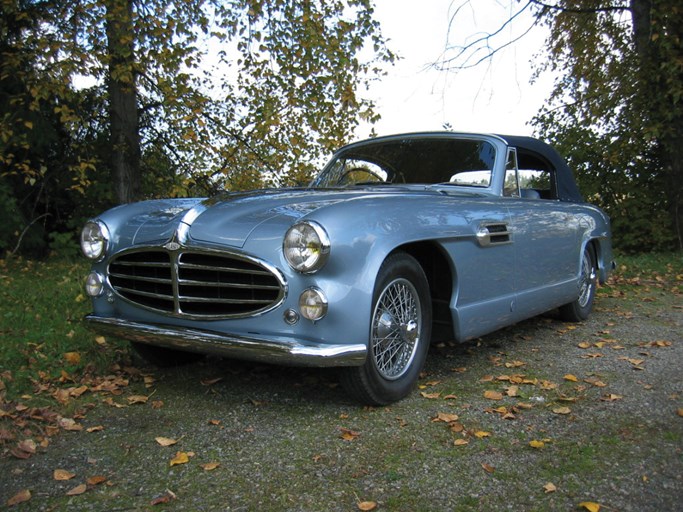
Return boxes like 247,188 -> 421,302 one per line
498,135 -> 584,203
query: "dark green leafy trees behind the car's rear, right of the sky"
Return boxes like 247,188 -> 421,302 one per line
533,0 -> 683,251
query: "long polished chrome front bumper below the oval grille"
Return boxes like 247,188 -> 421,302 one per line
85,315 -> 367,367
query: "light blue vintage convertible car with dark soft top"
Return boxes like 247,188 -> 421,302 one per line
81,132 -> 613,404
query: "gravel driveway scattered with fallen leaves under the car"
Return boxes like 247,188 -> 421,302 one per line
0,283 -> 683,511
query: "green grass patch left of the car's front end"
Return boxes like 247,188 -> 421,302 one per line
0,259 -> 125,401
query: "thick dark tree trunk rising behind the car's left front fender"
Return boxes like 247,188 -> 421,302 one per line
106,0 -> 141,203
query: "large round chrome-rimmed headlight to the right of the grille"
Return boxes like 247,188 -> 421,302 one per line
282,221 -> 330,274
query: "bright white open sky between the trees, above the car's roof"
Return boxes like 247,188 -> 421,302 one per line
356,0 -> 552,138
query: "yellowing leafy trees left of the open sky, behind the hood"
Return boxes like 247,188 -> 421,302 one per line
0,0 -> 394,252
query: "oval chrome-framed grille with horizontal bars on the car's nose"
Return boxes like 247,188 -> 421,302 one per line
108,250 -> 285,318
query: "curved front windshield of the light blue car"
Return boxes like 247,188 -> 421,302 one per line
312,137 -> 496,188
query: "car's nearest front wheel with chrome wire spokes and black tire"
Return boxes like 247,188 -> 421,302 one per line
341,253 -> 432,405
